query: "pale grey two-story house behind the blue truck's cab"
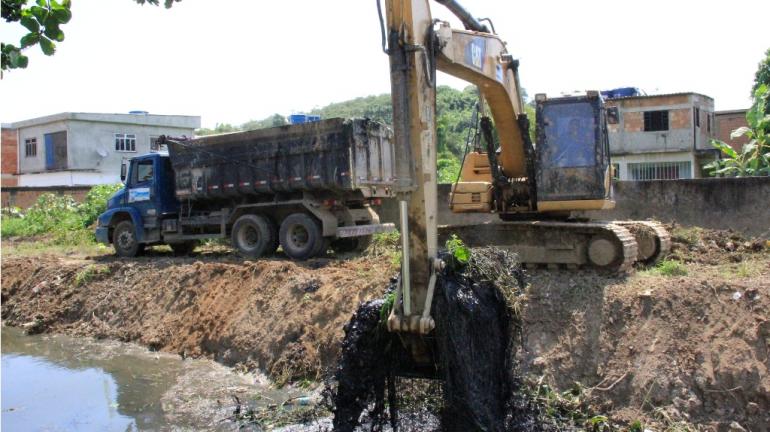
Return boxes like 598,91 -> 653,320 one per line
2,111 -> 200,186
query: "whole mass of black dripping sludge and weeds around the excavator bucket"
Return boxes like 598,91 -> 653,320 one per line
329,248 -> 549,432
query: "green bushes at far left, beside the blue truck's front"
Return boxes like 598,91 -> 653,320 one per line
0,184 -> 122,245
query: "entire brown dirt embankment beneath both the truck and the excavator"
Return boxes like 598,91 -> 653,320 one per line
2,230 -> 770,431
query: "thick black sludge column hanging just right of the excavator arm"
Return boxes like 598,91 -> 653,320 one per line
433,270 -> 513,432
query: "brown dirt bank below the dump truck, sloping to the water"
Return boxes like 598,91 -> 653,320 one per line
2,256 -> 394,381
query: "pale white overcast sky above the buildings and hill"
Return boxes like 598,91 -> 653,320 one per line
0,0 -> 770,127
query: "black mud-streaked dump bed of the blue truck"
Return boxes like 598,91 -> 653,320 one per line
167,119 -> 395,200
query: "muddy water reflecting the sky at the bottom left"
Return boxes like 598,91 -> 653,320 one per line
2,327 -> 297,431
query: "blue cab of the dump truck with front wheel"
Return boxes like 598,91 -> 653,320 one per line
96,153 -> 194,256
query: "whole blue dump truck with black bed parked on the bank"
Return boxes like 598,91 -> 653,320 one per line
96,119 -> 399,260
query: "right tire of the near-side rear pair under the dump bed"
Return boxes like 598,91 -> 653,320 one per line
278,213 -> 325,261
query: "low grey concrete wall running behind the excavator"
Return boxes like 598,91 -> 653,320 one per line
377,177 -> 770,238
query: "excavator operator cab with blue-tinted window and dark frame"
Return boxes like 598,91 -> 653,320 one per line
535,92 -> 614,212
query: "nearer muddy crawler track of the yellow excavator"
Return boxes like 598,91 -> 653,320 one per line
439,221 -> 640,273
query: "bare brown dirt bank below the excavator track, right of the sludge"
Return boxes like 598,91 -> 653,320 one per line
520,262 -> 770,431
